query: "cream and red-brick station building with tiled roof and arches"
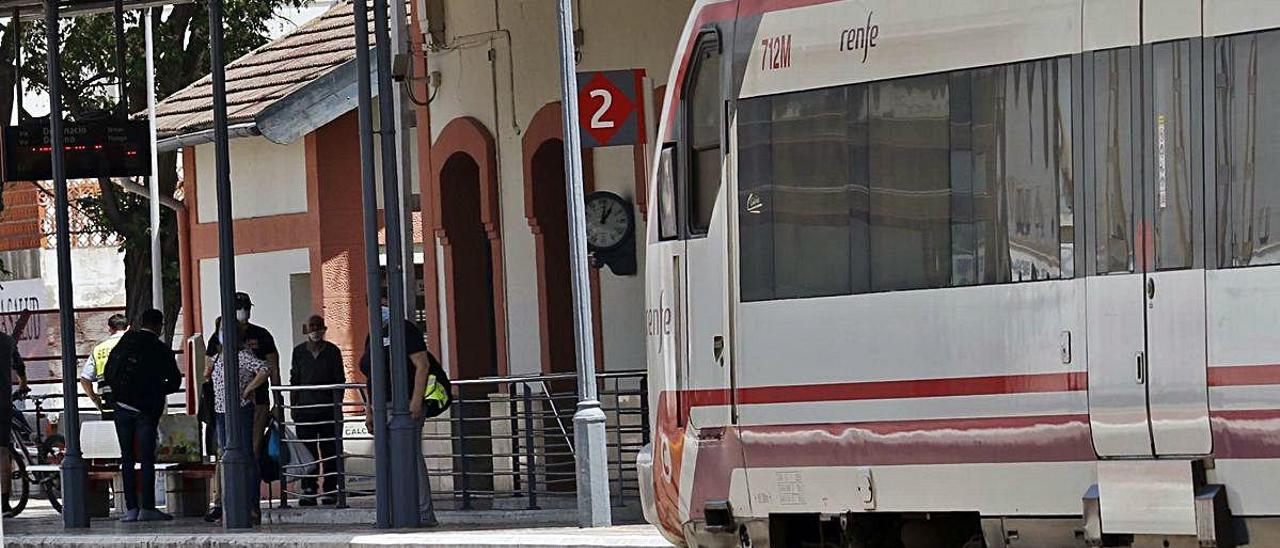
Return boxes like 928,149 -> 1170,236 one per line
157,0 -> 692,380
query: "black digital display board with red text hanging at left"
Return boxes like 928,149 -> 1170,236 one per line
4,120 -> 151,182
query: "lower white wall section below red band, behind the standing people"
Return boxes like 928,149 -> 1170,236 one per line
200,248 -> 311,382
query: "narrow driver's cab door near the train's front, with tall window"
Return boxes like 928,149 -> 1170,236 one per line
678,27 -> 732,429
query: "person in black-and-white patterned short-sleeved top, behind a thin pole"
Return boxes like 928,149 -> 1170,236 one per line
210,322 -> 270,522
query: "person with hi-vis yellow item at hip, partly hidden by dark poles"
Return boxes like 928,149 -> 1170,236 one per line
360,296 -> 448,528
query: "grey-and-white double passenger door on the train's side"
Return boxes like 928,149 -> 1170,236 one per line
1085,27 -> 1212,457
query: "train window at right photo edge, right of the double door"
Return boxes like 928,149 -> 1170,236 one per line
1215,31 -> 1280,268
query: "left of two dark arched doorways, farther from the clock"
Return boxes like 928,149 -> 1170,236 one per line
440,152 -> 498,379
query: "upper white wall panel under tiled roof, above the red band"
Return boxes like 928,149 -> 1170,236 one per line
196,137 -> 309,223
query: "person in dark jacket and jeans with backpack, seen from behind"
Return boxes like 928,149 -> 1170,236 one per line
102,309 -> 182,522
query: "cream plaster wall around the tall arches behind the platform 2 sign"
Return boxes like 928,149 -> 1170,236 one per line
424,0 -> 692,374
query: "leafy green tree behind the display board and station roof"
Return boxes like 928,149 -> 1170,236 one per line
13,0 -> 303,339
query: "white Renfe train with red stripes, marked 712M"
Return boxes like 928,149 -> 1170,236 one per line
639,0 -> 1280,548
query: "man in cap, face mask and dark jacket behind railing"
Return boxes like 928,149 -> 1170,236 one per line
289,315 -> 347,506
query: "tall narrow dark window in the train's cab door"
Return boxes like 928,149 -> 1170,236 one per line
684,31 -> 724,236
